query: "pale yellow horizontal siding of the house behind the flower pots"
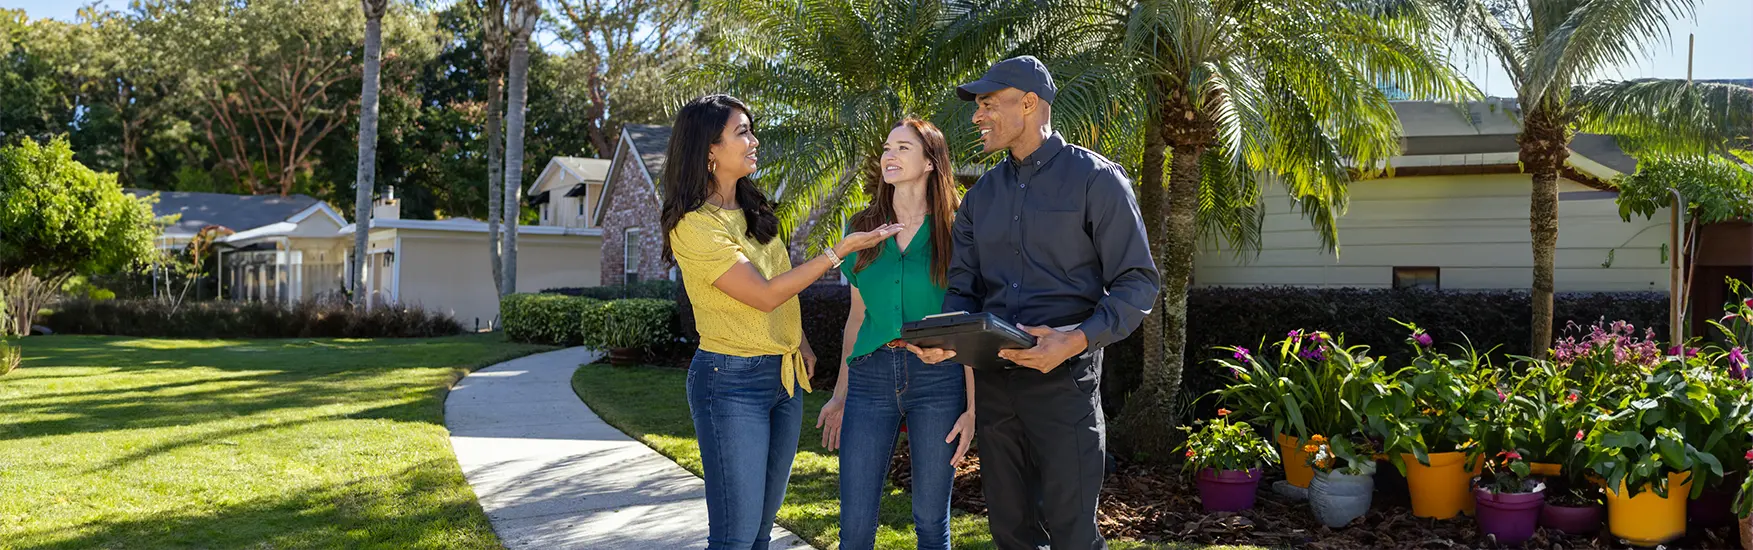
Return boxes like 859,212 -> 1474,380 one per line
1194,173 -> 1667,293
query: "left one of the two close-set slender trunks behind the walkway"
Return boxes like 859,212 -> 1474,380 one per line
480,0 -> 507,294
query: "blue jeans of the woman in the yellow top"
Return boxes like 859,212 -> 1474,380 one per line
687,352 -> 803,550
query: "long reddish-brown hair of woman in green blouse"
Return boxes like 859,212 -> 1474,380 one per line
850,117 -> 962,286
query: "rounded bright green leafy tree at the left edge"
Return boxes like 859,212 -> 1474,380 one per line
0,138 -> 158,333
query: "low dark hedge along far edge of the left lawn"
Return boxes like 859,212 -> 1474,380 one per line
42,300 -> 463,338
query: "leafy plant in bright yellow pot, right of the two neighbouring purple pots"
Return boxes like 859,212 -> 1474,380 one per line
1583,357 -> 1723,546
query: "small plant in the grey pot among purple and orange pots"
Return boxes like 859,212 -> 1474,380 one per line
1302,434 -> 1376,529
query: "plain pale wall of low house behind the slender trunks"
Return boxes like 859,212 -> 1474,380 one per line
396,229 -> 601,329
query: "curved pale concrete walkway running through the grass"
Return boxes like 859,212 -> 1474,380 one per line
444,349 -> 810,550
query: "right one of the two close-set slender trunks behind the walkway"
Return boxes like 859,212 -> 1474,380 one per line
500,0 -> 542,294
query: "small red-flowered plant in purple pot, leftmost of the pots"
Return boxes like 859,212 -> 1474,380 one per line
1182,408 -> 1278,511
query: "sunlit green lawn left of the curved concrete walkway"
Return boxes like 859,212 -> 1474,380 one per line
0,335 -> 543,548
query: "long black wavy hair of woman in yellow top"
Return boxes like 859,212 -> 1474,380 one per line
663,95 -> 778,261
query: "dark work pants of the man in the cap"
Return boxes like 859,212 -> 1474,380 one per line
975,350 -> 1108,550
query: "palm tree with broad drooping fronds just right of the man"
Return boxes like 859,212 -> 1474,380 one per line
1055,0 -> 1473,457
